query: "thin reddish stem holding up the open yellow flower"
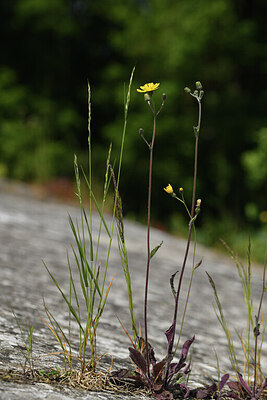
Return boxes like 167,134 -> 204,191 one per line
144,108 -> 157,378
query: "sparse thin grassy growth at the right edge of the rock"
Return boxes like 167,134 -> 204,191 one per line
206,241 -> 267,400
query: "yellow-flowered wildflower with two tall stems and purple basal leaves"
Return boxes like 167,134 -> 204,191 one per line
112,82 -> 204,400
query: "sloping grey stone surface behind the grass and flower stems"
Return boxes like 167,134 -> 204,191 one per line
0,189 -> 267,400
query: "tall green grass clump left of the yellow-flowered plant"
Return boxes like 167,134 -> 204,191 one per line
45,69 -> 134,373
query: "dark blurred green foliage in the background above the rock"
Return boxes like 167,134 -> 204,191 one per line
0,0 -> 267,256
